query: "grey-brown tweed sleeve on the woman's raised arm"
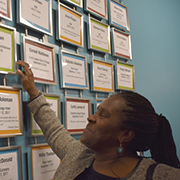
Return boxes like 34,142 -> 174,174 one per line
28,94 -> 80,160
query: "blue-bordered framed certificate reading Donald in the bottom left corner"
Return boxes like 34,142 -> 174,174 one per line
0,146 -> 23,180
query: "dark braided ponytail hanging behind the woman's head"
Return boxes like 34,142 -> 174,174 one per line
150,115 -> 180,168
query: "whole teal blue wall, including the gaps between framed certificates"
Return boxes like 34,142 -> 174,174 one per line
0,0 -> 180,179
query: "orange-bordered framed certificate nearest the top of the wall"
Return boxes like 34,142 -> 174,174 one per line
57,1 -> 84,47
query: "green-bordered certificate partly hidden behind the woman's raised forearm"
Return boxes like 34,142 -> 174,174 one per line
31,95 -> 60,135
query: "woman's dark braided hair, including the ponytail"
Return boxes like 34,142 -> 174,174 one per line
115,91 -> 180,168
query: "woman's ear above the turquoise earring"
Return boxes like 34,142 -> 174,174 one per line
118,129 -> 135,142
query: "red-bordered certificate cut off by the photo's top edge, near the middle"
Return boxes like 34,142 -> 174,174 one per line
86,0 -> 107,18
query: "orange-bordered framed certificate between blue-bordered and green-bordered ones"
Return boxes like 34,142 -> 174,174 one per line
92,59 -> 114,92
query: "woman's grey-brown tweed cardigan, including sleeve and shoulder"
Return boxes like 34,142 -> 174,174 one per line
28,95 -> 180,180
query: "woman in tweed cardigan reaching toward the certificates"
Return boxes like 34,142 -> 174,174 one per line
17,61 -> 180,180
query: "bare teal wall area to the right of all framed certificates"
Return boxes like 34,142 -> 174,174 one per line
124,0 -> 180,158
